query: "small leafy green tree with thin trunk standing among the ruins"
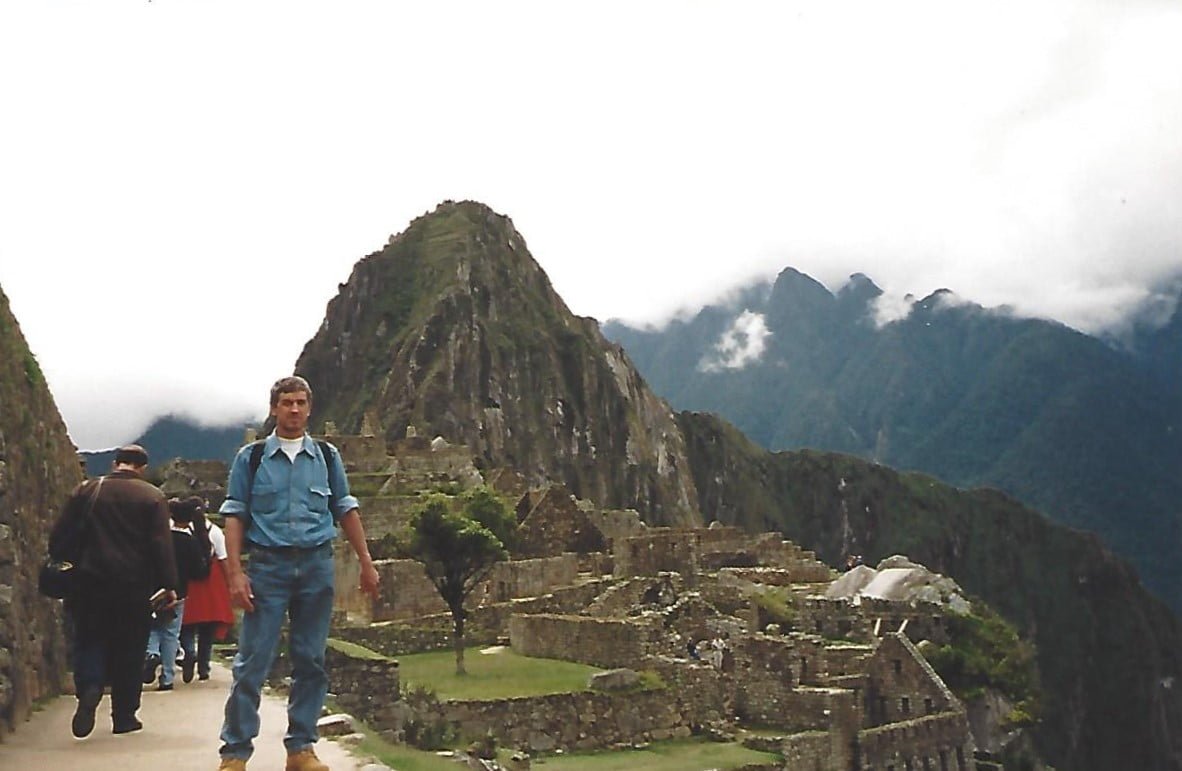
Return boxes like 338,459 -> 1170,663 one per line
404,487 -> 517,674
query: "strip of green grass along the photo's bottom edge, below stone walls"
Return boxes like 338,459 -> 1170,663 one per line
362,739 -> 778,771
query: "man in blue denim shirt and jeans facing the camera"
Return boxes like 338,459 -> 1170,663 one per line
219,377 -> 378,771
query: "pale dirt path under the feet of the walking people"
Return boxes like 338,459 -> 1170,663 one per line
0,665 -> 364,771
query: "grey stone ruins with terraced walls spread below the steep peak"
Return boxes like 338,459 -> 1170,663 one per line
174,432 -> 975,771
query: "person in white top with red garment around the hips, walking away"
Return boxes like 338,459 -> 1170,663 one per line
181,495 -> 234,682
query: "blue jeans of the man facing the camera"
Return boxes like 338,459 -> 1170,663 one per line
221,543 -> 333,759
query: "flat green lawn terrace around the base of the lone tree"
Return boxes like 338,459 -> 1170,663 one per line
398,647 -> 602,700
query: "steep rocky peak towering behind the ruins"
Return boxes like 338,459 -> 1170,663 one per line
296,202 -> 697,525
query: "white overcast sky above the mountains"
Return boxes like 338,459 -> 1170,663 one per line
0,0 -> 1182,449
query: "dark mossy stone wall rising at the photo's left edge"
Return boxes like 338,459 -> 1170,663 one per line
0,291 -> 82,736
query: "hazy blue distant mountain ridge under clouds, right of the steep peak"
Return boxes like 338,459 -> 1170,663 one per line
604,268 -> 1182,610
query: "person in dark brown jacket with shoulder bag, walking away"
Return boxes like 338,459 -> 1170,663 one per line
50,445 -> 177,738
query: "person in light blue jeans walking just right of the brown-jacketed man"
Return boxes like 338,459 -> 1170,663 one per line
143,495 -> 209,691
